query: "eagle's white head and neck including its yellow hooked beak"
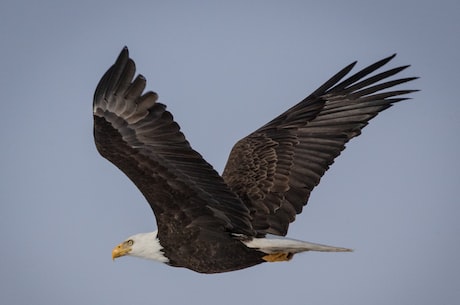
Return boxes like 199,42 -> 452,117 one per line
112,231 -> 169,263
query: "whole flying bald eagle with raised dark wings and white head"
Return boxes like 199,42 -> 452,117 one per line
93,47 -> 416,273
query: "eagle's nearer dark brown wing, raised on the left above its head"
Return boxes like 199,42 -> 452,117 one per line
93,47 -> 254,246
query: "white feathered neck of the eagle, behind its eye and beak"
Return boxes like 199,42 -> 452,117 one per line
130,231 -> 169,263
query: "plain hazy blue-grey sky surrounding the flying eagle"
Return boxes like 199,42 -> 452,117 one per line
0,0 -> 460,305
